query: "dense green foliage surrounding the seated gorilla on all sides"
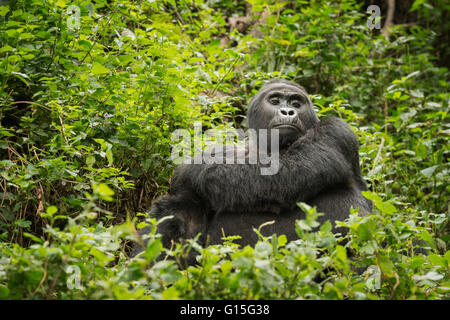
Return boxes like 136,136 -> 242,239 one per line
0,0 -> 450,299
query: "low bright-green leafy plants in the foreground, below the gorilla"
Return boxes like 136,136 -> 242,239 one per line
0,198 -> 450,299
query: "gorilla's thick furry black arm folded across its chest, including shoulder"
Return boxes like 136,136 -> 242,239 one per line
171,118 -> 359,213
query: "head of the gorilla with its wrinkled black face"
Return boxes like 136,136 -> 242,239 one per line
248,80 -> 319,146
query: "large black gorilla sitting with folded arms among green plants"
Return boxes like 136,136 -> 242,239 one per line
134,79 -> 371,264
